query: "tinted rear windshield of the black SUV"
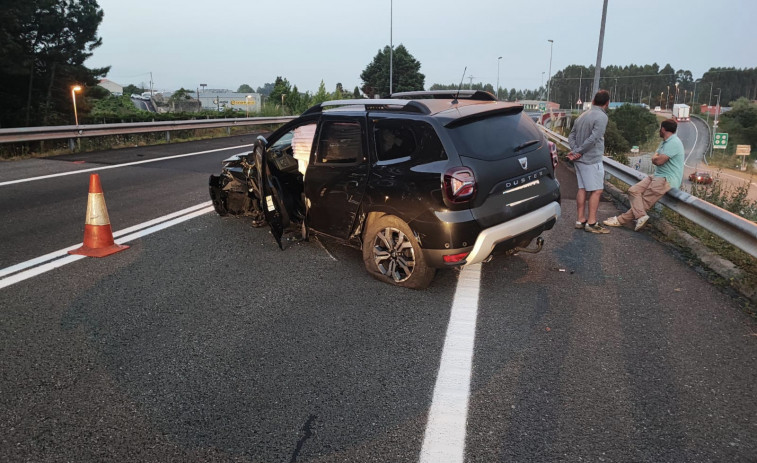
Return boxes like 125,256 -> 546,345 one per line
449,113 -> 543,161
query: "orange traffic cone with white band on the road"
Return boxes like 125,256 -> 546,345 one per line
68,174 -> 129,257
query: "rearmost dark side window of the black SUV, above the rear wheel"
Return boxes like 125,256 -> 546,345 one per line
373,119 -> 447,161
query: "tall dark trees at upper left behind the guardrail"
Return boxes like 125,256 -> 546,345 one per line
0,0 -> 110,127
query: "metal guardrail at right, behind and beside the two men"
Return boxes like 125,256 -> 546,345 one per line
542,127 -> 757,257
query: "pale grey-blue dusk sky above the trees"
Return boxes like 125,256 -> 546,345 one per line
85,0 -> 757,93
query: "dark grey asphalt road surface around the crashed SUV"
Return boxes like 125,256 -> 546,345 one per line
0,137 -> 757,462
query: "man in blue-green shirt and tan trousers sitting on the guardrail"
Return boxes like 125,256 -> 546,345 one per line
602,119 -> 684,231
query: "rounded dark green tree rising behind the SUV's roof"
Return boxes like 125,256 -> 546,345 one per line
360,44 -> 426,98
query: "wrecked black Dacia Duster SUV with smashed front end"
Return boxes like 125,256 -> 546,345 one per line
210,91 -> 560,288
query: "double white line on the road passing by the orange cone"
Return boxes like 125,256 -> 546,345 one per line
0,203 -> 213,289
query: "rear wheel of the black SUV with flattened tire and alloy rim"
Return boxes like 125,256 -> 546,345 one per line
363,215 -> 436,289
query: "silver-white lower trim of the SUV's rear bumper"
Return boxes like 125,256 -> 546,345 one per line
465,201 -> 560,265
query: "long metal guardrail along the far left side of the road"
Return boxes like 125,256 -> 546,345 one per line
0,116 -> 294,143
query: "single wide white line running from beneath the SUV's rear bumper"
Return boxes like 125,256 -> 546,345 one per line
420,264 -> 481,463
